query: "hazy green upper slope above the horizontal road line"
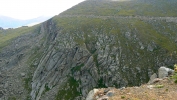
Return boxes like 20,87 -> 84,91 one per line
61,0 -> 177,17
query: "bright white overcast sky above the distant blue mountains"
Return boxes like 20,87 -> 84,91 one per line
0,0 -> 85,20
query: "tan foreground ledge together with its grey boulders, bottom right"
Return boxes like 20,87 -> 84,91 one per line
86,67 -> 177,100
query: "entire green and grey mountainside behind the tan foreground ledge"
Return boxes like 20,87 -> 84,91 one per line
0,0 -> 177,100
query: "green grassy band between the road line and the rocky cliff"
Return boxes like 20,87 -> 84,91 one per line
54,16 -> 177,51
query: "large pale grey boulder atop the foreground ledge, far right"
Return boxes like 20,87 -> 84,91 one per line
158,66 -> 174,78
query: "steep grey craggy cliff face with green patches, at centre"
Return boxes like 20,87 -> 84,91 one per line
31,16 -> 176,99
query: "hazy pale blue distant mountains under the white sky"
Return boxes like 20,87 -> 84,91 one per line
0,16 -> 50,28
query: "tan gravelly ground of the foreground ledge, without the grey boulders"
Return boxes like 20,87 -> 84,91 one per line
88,78 -> 177,100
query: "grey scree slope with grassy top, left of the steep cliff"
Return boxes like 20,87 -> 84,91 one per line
0,26 -> 43,100
